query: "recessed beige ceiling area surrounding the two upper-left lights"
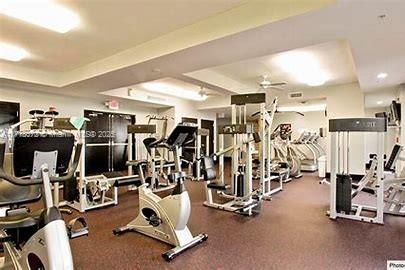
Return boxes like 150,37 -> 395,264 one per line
0,0 -> 243,71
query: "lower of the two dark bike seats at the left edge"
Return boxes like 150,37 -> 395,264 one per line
0,209 -> 43,230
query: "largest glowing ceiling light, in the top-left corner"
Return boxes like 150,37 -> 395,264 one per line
0,0 -> 80,33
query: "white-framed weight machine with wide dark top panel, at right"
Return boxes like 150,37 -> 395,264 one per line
328,118 -> 387,224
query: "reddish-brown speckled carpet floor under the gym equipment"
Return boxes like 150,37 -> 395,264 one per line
60,175 -> 405,270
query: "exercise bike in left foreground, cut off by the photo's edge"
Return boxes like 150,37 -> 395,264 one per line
0,127 -> 88,270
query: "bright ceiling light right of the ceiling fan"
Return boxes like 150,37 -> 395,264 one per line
275,52 -> 329,86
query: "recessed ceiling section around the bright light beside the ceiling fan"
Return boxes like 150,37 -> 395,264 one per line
188,41 -> 357,92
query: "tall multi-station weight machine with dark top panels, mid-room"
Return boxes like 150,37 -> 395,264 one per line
202,93 -> 276,216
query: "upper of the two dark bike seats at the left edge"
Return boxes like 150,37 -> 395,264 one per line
0,179 -> 42,207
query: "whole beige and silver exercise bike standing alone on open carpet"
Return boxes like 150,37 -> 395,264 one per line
113,125 -> 208,261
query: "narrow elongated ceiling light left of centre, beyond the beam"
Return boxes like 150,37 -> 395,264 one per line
141,82 -> 207,101
